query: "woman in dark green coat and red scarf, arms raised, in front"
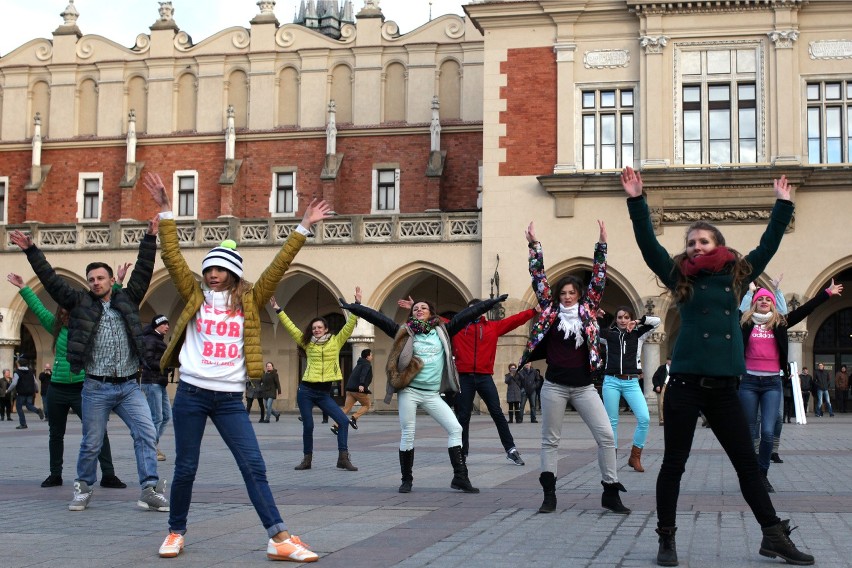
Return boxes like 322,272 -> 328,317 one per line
621,167 -> 814,566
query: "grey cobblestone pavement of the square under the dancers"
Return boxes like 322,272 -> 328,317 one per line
0,413 -> 852,568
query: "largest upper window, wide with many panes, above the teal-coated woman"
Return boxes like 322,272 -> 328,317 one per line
678,46 -> 763,165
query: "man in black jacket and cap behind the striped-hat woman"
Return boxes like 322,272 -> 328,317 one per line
142,314 -> 172,461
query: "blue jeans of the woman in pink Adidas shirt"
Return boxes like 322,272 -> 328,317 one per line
739,374 -> 784,471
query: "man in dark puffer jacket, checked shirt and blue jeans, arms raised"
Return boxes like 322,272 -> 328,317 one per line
9,226 -> 169,512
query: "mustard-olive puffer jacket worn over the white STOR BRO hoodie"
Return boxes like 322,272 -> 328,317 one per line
160,219 -> 305,379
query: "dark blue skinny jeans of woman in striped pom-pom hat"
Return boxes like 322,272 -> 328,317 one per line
169,381 -> 287,538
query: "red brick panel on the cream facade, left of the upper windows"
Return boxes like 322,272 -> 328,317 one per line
500,47 -> 556,176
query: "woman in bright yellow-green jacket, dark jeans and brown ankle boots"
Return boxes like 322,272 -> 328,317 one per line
269,296 -> 360,471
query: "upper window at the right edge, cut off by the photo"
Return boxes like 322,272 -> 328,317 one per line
807,80 -> 852,164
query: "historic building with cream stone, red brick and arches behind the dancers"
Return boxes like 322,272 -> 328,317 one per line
0,0 -> 852,408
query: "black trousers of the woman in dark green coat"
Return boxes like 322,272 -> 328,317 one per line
657,375 -> 781,528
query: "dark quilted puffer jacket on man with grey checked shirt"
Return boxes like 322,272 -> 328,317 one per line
24,233 -> 157,373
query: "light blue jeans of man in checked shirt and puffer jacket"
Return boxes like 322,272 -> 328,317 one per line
77,377 -> 160,489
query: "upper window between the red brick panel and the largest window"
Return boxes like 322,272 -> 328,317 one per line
581,87 -> 635,170
